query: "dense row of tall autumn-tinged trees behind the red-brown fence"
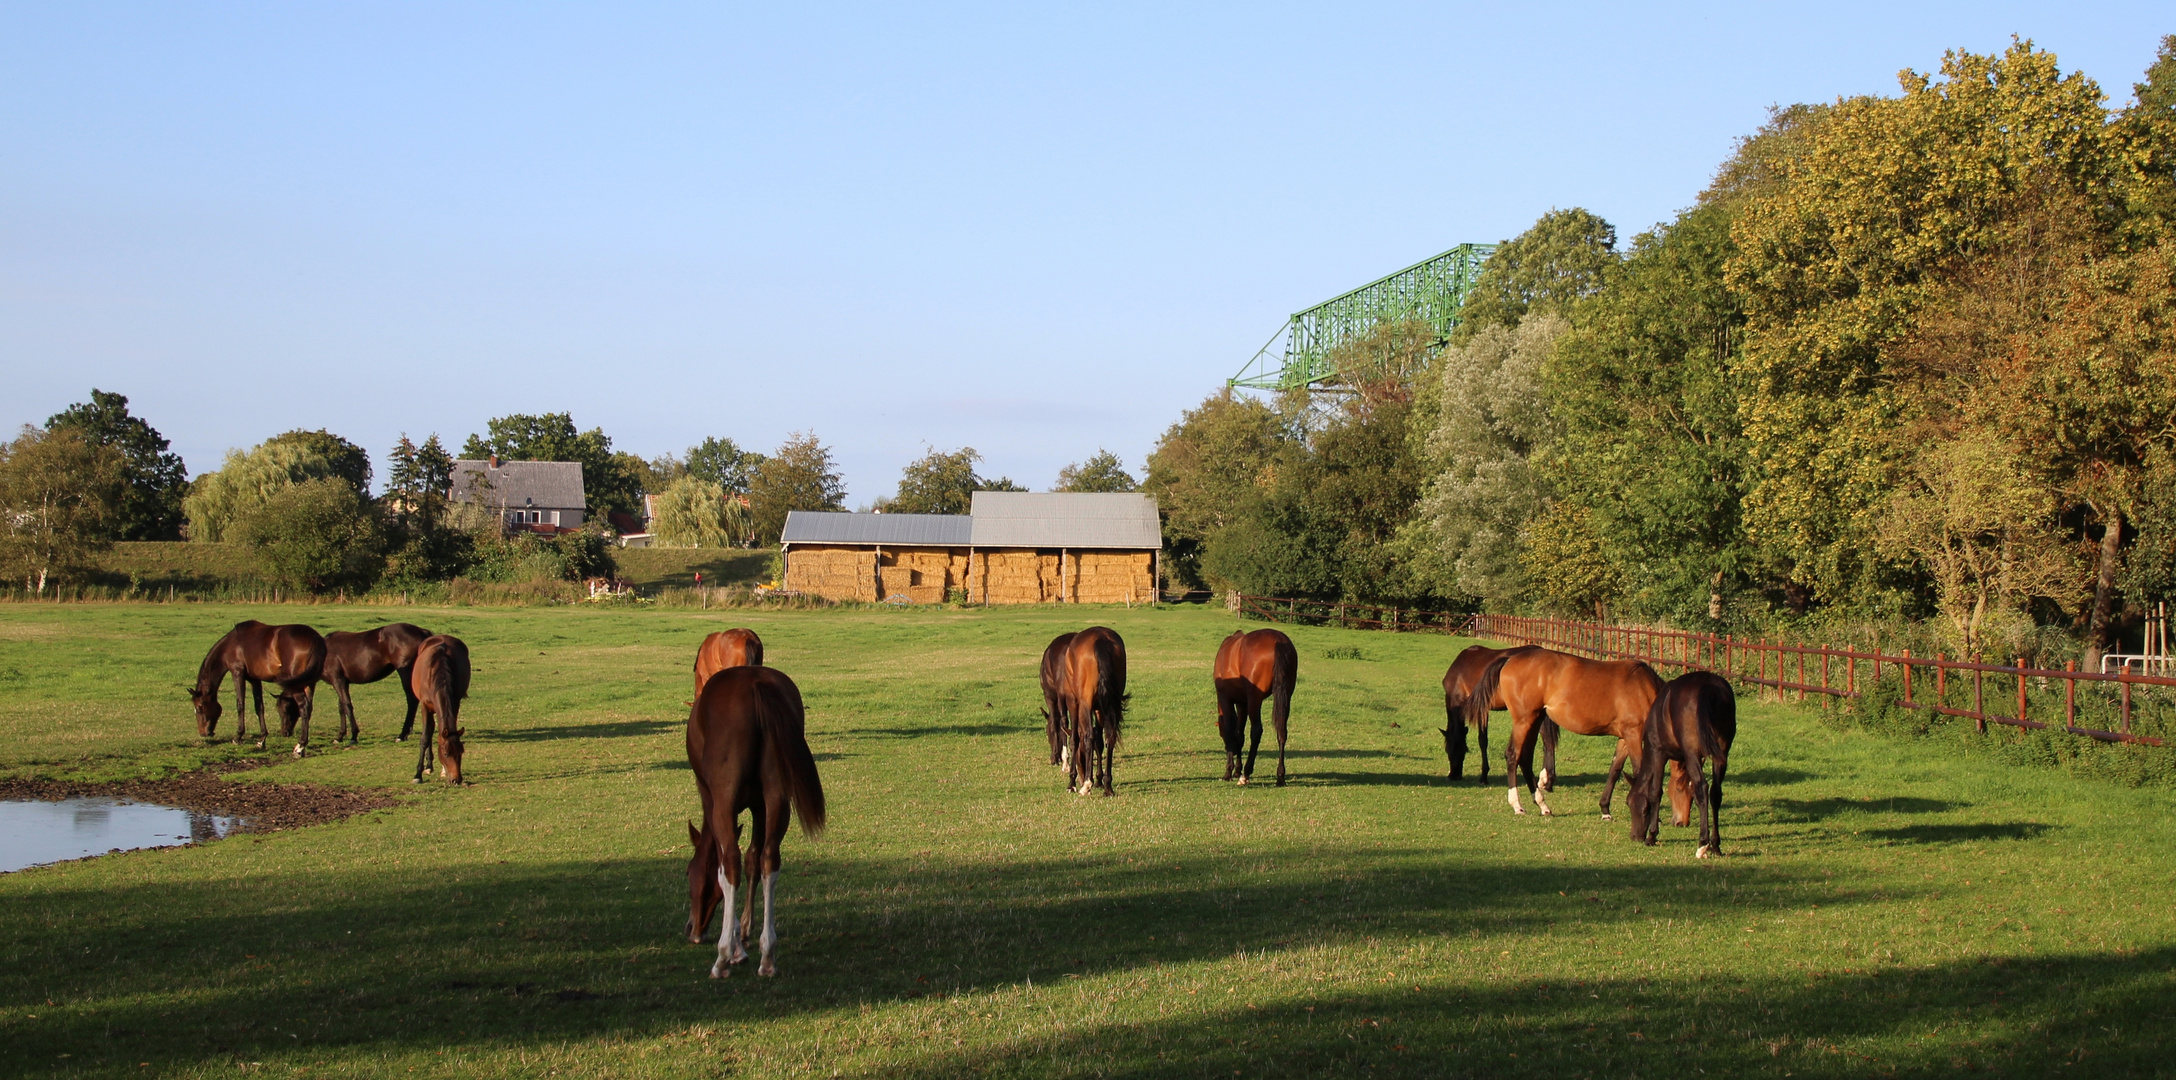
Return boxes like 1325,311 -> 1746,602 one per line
1145,37 -> 2176,660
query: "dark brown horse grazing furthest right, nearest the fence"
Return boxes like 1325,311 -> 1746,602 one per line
1625,671 -> 1739,858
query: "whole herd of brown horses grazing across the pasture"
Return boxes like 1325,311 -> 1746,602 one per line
189,621 -> 1736,978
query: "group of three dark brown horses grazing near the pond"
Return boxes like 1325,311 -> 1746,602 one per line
189,618 -> 468,784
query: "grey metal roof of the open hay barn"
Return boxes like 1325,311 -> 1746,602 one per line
781,492 -> 1164,551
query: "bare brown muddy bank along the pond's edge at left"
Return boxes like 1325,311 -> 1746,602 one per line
0,762 -> 398,832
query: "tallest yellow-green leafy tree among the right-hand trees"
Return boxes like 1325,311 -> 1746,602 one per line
1726,41 -> 2124,603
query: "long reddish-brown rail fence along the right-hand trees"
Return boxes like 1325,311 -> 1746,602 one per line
1238,597 -> 2176,747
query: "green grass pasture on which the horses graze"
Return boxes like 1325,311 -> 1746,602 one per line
0,605 -> 2176,1078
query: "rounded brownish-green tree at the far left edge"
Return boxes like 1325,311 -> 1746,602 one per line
0,427 -> 126,594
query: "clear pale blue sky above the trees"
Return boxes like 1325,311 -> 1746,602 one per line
0,2 -> 2176,505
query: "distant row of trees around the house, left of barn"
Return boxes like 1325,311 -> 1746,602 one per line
0,390 -> 1134,592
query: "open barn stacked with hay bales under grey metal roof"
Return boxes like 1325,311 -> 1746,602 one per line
779,492 -> 1164,603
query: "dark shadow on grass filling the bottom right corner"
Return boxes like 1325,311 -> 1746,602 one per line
861,949 -> 2176,1078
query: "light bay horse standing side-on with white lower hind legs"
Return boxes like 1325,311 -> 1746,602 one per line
1467,649 -> 1662,821
